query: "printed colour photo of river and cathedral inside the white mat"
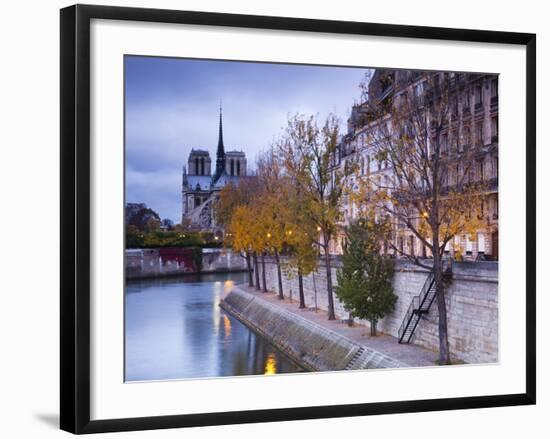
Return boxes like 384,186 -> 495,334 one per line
124,54 -> 500,383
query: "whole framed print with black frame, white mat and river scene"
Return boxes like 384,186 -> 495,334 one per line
61,5 -> 536,433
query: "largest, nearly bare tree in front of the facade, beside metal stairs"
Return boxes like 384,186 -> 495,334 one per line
355,71 -> 483,364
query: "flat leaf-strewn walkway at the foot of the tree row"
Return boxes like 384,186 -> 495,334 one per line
231,284 -> 438,367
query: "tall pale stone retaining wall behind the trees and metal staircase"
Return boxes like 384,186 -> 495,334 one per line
258,258 -> 498,363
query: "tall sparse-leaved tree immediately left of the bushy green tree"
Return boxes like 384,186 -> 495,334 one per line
278,115 -> 349,320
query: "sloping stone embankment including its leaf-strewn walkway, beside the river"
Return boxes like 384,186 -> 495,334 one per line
220,285 -> 438,371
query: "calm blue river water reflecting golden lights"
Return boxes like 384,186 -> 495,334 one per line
125,273 -> 299,381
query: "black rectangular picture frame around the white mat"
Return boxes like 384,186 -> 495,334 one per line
60,5 -> 536,434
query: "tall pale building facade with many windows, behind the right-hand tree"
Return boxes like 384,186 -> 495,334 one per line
332,69 -> 498,260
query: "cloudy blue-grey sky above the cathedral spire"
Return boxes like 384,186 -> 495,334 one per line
125,56 -> 366,223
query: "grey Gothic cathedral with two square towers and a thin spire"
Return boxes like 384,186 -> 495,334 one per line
181,107 -> 246,230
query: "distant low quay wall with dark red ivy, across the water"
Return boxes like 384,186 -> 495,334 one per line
124,247 -> 246,279
